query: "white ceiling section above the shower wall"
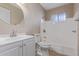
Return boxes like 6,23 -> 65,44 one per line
41,3 -> 67,10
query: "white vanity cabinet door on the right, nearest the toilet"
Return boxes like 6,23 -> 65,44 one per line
23,38 -> 35,56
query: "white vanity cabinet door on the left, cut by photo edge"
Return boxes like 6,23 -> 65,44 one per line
0,42 -> 22,56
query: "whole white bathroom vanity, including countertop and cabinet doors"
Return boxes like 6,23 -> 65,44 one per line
0,35 -> 35,56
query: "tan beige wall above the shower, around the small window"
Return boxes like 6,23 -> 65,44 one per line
45,4 -> 74,20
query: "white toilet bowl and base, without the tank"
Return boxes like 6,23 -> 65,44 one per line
37,42 -> 50,56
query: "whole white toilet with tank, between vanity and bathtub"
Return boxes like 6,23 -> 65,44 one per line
35,34 -> 50,56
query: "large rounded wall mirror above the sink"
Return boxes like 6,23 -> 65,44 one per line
0,3 -> 24,25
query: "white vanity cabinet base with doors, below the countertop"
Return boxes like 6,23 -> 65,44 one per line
0,37 -> 35,56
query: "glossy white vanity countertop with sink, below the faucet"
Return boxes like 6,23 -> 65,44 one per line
0,35 -> 33,45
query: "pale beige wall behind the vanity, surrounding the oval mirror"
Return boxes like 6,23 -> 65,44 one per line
0,3 -> 44,34
